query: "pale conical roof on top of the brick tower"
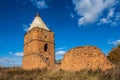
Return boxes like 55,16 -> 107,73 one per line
28,13 -> 49,31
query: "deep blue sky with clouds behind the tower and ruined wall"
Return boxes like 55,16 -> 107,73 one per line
0,0 -> 120,66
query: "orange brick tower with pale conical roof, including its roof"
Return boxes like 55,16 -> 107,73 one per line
22,14 -> 54,70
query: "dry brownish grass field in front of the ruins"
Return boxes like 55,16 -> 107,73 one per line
0,65 -> 120,80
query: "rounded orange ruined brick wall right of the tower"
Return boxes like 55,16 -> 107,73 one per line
61,46 -> 113,71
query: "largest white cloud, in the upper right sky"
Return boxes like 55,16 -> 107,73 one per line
73,0 -> 115,25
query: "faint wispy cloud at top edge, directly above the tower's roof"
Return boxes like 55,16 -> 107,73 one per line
30,0 -> 48,9
